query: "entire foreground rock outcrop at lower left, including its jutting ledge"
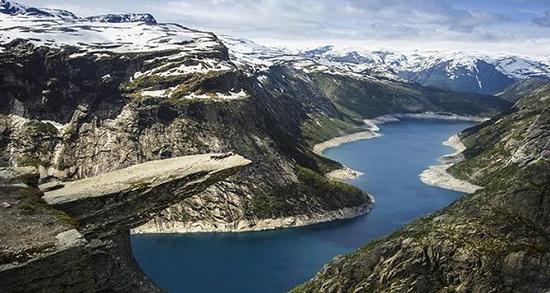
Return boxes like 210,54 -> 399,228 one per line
0,154 -> 250,292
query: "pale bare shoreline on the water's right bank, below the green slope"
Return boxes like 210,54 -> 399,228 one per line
418,134 -> 483,193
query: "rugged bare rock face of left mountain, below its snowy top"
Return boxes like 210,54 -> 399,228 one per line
0,39 -> 376,232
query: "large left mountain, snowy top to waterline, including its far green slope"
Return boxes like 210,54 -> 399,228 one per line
0,0 -> 508,232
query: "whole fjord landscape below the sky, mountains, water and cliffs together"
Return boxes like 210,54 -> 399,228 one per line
0,0 -> 550,292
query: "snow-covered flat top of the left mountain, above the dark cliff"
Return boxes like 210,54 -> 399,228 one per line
0,1 -> 224,53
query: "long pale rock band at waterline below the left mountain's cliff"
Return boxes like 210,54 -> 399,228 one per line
130,202 -> 374,235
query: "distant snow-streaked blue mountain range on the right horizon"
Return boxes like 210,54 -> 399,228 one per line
304,46 -> 550,94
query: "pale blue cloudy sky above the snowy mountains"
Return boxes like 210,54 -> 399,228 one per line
19,0 -> 550,56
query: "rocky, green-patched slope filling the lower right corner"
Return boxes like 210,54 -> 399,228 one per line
294,86 -> 550,292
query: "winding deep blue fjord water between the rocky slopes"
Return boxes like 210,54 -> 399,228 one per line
132,119 -> 473,293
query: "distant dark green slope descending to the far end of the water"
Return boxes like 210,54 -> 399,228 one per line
310,72 -> 509,118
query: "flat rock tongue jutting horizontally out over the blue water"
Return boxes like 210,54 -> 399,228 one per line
43,154 -> 251,238
